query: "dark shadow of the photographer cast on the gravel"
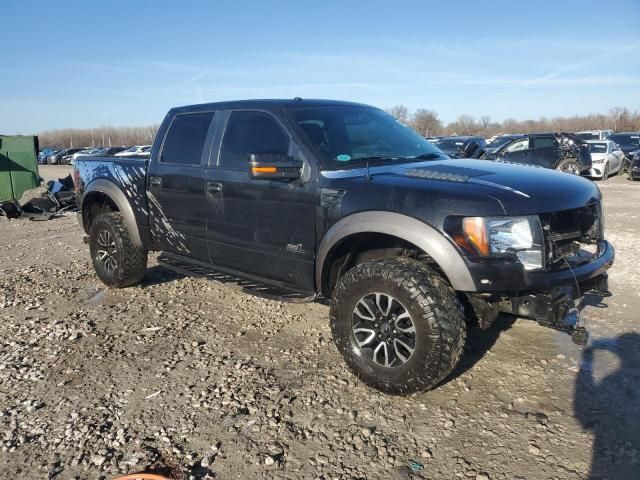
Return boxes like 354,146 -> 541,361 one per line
573,333 -> 640,480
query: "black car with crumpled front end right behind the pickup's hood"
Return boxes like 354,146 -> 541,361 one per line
480,133 -> 591,176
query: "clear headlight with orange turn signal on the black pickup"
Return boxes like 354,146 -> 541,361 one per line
454,216 -> 544,270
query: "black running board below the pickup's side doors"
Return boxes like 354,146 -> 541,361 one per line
158,253 -> 317,303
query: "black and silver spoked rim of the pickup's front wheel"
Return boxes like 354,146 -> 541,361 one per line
352,293 -> 417,368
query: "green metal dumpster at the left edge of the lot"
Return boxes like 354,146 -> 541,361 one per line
0,135 -> 40,202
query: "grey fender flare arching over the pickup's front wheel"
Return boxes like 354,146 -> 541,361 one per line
315,211 -> 476,292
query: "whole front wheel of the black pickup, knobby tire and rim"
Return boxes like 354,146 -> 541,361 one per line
330,259 -> 466,395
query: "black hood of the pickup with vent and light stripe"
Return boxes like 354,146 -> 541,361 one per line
322,159 -> 601,215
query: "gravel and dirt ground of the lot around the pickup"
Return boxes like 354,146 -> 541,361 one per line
0,167 -> 640,480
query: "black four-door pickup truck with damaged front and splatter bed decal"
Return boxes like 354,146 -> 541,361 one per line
74,98 -> 614,394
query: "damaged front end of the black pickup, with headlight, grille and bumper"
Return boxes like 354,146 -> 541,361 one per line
449,201 -> 615,343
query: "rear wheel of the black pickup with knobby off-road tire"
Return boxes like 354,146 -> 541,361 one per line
89,212 -> 147,288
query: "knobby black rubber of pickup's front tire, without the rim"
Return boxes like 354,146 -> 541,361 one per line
330,258 -> 466,395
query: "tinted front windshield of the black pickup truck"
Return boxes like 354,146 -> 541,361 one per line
288,105 -> 446,169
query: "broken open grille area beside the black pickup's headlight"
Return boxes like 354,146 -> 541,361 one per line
540,202 -> 603,270
